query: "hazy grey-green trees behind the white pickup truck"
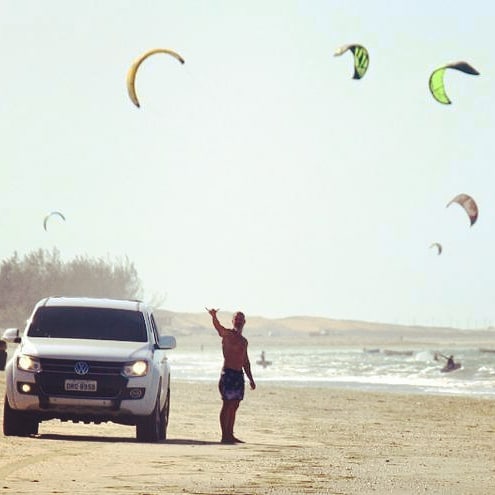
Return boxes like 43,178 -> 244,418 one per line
0,249 -> 142,328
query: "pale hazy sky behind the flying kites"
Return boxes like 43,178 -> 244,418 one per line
0,0 -> 495,328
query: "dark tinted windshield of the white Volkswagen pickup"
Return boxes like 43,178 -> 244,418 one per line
27,307 -> 148,342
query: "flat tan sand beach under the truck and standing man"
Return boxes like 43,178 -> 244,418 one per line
0,372 -> 495,495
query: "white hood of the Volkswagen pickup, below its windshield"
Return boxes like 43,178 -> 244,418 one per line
18,337 -> 151,361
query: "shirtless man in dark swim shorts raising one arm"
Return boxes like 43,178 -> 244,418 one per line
206,308 -> 256,443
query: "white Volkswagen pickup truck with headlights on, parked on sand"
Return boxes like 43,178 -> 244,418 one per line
3,297 -> 176,442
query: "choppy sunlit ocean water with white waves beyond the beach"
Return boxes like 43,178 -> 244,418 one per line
169,346 -> 495,399
